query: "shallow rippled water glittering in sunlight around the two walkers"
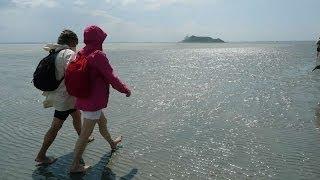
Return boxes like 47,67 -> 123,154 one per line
0,42 -> 320,179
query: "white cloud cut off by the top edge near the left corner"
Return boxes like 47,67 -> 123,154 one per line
11,0 -> 58,8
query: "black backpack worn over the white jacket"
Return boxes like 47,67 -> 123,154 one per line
32,49 -> 64,91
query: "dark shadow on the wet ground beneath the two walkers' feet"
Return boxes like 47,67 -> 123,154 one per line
32,152 -> 138,180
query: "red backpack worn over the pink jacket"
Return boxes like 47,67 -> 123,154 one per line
65,53 -> 90,98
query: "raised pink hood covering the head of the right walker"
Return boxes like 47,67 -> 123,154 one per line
83,25 -> 107,47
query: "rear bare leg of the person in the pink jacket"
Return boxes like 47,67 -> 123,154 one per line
70,119 -> 96,173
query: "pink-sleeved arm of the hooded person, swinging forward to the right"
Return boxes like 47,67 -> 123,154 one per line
92,51 -> 131,96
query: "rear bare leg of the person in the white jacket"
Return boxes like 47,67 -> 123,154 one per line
35,117 -> 64,162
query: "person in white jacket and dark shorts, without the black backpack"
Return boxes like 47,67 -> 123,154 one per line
35,29 -> 94,165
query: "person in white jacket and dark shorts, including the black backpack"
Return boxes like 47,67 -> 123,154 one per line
33,30 -> 93,165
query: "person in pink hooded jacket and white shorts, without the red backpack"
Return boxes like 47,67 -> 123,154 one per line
70,26 -> 131,173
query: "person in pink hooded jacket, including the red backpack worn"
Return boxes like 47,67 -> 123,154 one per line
66,26 -> 131,173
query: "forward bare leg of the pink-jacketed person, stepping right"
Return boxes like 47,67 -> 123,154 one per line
98,113 -> 122,150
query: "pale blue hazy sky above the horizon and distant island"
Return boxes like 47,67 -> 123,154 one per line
0,0 -> 320,43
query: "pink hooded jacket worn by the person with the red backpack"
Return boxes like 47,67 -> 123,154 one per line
75,26 -> 130,111
